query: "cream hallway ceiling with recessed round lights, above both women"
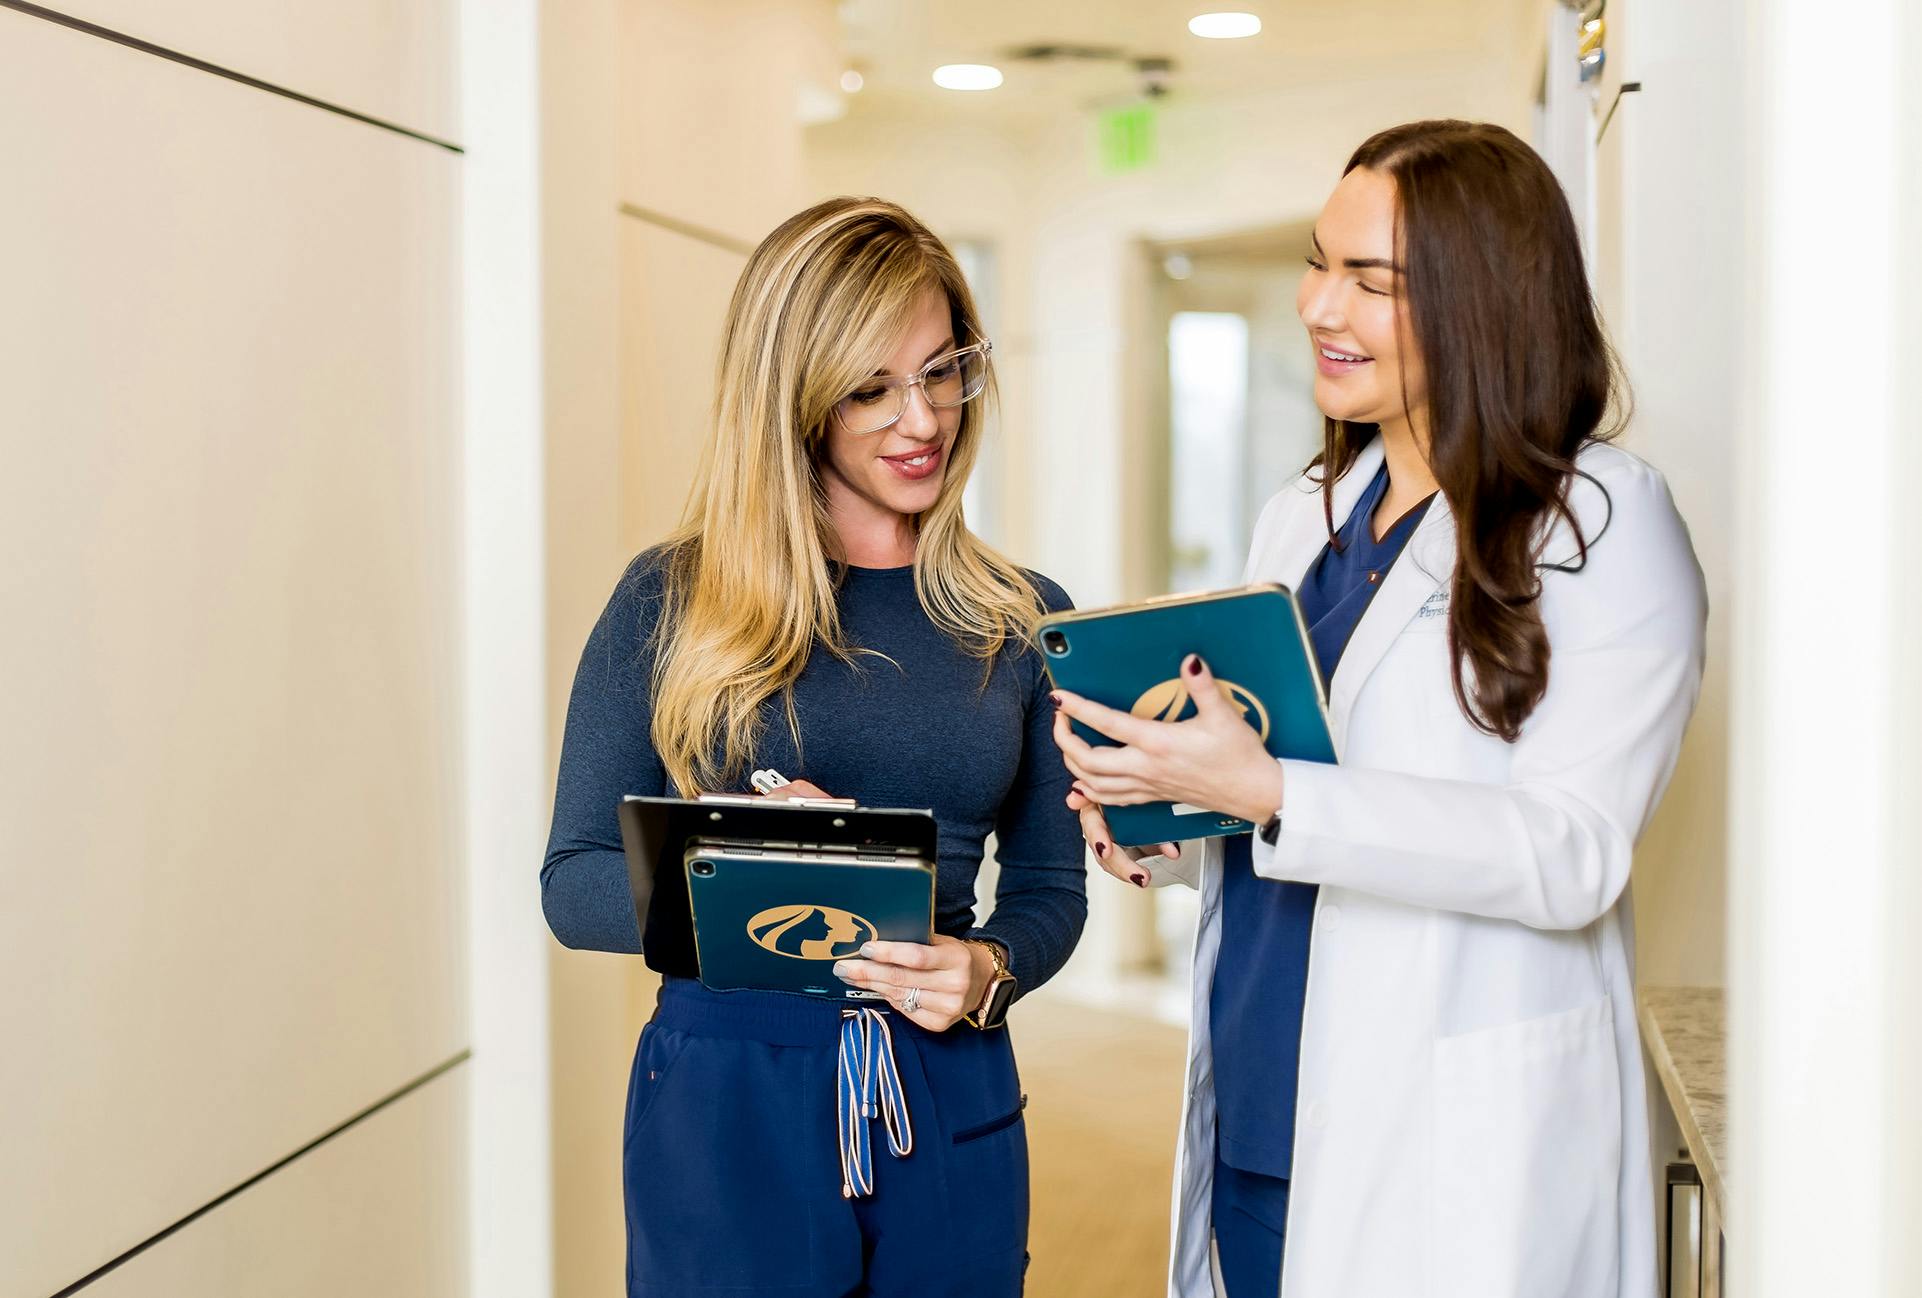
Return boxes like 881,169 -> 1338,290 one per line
838,0 -> 1516,117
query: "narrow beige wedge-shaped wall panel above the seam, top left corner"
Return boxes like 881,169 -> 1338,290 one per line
46,0 -> 459,142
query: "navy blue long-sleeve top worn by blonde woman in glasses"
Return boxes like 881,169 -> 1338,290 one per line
540,550 -> 1088,990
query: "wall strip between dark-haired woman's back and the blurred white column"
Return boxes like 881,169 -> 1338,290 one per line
1593,0 -> 1749,986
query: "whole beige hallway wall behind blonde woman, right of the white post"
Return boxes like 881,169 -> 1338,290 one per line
529,0 -> 840,1298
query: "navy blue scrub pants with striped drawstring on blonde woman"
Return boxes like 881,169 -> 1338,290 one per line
623,979 -> 1028,1298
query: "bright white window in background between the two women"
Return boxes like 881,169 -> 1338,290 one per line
1169,312 -> 1247,590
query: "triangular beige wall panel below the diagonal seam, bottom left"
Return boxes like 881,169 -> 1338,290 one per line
83,1069 -> 467,1298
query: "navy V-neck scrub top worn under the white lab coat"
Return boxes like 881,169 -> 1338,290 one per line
1209,463 -> 1434,1179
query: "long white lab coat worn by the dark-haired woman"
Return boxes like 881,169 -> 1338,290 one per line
1155,438 -> 1707,1298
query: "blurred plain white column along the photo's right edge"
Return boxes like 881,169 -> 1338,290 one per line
1729,0 -> 1922,1298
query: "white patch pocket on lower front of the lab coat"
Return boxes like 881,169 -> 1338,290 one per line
1428,996 -> 1622,1298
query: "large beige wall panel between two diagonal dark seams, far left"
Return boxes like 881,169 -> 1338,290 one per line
0,12 -> 461,1296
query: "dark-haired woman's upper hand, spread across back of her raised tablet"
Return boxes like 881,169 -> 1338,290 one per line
1053,654 -> 1282,825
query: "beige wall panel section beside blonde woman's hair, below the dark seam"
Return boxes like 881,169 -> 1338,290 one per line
609,217 -> 744,565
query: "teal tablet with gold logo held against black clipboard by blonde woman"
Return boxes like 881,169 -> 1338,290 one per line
686,840 -> 934,1000
